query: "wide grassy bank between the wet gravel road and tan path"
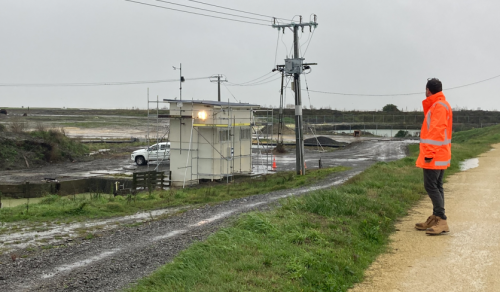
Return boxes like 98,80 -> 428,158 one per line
130,126 -> 500,291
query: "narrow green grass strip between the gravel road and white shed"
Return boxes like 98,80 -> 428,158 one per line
0,167 -> 346,222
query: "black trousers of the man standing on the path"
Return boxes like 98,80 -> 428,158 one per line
424,168 -> 446,220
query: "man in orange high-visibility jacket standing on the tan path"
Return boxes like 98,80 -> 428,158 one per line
415,78 -> 453,235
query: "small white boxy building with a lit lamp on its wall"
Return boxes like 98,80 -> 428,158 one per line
164,99 -> 260,186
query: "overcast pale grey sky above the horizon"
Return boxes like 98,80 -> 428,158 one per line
0,0 -> 500,110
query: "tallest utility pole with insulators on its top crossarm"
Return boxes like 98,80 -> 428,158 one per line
273,15 -> 318,175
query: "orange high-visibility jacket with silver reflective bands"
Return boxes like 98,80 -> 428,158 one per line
417,92 -> 453,169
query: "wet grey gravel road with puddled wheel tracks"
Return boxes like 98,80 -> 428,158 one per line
0,141 -> 414,291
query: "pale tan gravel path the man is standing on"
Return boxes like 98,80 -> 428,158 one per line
350,144 -> 500,292
